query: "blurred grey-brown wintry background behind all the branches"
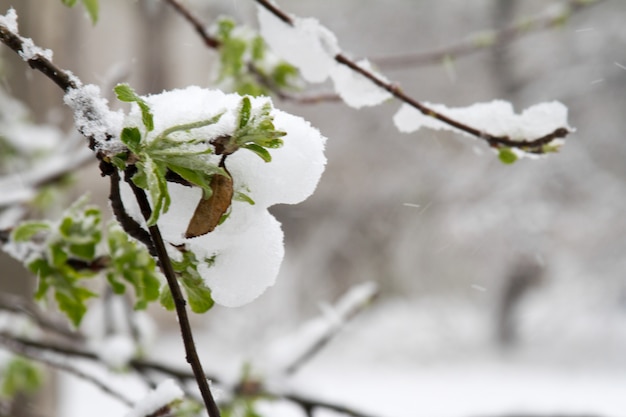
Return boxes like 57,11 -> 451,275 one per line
0,0 -> 626,416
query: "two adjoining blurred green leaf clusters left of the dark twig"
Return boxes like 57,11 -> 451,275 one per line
11,198 -> 168,326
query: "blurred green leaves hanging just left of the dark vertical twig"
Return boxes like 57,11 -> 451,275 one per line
106,223 -> 161,310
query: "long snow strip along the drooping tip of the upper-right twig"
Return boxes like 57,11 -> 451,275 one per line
393,100 -> 569,140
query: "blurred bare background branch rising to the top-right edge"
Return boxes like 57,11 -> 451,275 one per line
372,0 -> 604,69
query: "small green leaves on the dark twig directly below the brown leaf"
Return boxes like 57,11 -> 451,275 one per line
160,250 -> 215,314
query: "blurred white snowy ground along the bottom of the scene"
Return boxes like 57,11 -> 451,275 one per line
58,290 -> 626,417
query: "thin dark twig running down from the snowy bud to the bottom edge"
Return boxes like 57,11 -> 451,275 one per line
125,167 -> 220,417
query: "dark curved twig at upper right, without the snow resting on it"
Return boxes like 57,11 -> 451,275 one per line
255,0 -> 570,154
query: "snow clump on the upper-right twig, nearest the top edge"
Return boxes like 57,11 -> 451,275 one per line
258,6 -> 340,83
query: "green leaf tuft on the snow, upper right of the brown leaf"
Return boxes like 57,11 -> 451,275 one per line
222,97 -> 287,162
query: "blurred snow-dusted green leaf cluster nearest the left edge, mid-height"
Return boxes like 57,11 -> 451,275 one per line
11,199 -> 102,326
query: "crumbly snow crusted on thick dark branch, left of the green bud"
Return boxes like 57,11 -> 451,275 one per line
64,84 -> 123,145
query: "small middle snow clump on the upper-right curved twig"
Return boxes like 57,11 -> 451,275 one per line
330,59 -> 391,109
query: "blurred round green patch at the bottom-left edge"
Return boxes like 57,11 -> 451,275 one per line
0,356 -> 43,398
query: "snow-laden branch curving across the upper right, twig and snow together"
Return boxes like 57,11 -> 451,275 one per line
256,0 -> 572,156
